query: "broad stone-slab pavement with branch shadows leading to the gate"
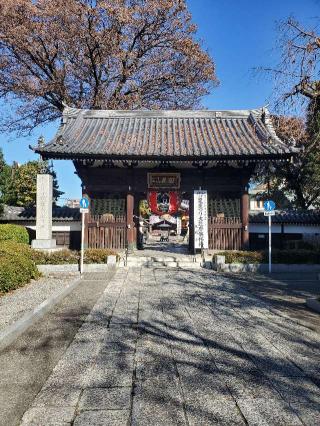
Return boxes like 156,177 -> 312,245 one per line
22,268 -> 320,426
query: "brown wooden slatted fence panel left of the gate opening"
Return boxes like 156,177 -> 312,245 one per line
87,215 -> 127,250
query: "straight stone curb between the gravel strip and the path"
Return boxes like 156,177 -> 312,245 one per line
0,278 -> 81,350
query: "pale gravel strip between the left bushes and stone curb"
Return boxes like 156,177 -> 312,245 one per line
0,274 -> 78,331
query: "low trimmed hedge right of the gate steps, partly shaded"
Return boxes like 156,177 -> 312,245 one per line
217,249 -> 320,264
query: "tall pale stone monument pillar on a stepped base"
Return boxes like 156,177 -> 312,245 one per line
32,174 -> 56,250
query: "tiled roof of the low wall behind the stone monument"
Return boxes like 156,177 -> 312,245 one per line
0,206 -> 80,222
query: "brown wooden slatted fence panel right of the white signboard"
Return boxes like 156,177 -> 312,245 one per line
208,217 -> 242,250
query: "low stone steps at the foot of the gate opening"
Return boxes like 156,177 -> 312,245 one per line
119,255 -> 209,269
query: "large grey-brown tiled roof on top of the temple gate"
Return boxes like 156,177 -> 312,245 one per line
34,108 -> 296,160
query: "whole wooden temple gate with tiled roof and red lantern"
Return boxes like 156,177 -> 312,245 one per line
34,108 -> 295,252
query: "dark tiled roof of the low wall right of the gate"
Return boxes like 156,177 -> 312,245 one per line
249,210 -> 320,225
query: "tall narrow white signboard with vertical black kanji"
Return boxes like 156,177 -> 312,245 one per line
193,190 -> 208,249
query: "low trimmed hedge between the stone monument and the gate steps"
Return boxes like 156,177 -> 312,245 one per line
32,249 -> 117,265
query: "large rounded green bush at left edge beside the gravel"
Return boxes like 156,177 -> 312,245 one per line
0,241 -> 40,293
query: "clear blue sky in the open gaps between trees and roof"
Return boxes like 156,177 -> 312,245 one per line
0,0 -> 320,203
